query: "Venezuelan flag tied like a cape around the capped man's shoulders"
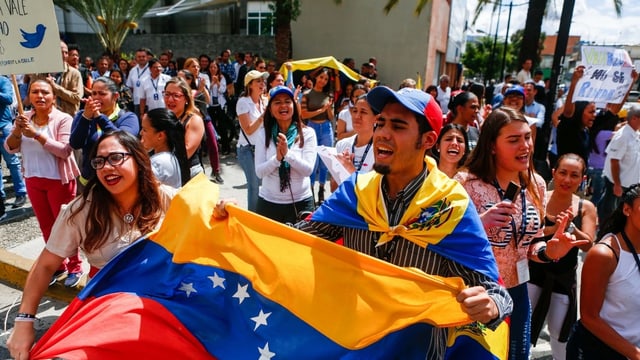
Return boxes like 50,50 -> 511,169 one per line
311,156 -> 509,359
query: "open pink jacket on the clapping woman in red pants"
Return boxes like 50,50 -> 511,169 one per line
4,108 -> 80,184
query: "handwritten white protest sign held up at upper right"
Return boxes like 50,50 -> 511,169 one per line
573,46 -> 633,104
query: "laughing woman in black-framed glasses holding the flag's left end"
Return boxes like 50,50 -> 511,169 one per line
8,130 -> 176,359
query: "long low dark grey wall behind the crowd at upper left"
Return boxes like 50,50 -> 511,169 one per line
64,34 -> 275,59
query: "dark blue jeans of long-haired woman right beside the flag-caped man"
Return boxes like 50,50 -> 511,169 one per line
507,283 -> 531,360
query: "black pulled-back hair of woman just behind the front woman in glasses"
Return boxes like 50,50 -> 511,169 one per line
147,108 -> 191,186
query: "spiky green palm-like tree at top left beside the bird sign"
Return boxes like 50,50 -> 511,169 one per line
53,0 -> 157,55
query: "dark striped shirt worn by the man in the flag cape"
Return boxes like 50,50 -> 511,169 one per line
296,168 -> 513,359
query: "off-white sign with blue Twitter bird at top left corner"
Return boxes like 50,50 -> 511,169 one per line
0,0 -> 63,75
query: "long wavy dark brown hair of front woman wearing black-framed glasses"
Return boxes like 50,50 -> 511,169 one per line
69,130 -> 163,252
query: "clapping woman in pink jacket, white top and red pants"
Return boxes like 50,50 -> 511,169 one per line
4,80 -> 82,287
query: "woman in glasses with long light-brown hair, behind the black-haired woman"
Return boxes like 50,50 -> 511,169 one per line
164,77 -> 204,178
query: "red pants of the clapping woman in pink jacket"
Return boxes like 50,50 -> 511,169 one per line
25,177 -> 82,273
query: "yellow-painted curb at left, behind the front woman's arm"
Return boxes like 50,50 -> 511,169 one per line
0,249 -> 87,303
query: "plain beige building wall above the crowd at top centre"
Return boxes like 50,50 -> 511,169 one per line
292,0 -> 449,88
